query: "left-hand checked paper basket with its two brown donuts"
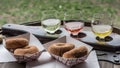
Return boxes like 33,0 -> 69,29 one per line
4,33 -> 44,63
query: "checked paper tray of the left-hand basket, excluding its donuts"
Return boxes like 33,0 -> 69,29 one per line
4,33 -> 44,62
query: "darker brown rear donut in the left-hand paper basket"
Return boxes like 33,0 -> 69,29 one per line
6,38 -> 29,49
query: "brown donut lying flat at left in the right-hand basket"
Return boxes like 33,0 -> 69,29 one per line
48,43 -> 75,56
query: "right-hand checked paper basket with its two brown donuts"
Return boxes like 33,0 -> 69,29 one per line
43,36 -> 92,67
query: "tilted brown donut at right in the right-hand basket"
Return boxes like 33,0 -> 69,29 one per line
62,46 -> 88,58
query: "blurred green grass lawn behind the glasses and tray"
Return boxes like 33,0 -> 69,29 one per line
0,0 -> 120,26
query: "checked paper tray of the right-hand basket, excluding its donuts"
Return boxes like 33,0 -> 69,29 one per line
43,36 -> 92,66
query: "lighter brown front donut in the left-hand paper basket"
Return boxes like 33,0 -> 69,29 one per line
14,46 -> 39,55
